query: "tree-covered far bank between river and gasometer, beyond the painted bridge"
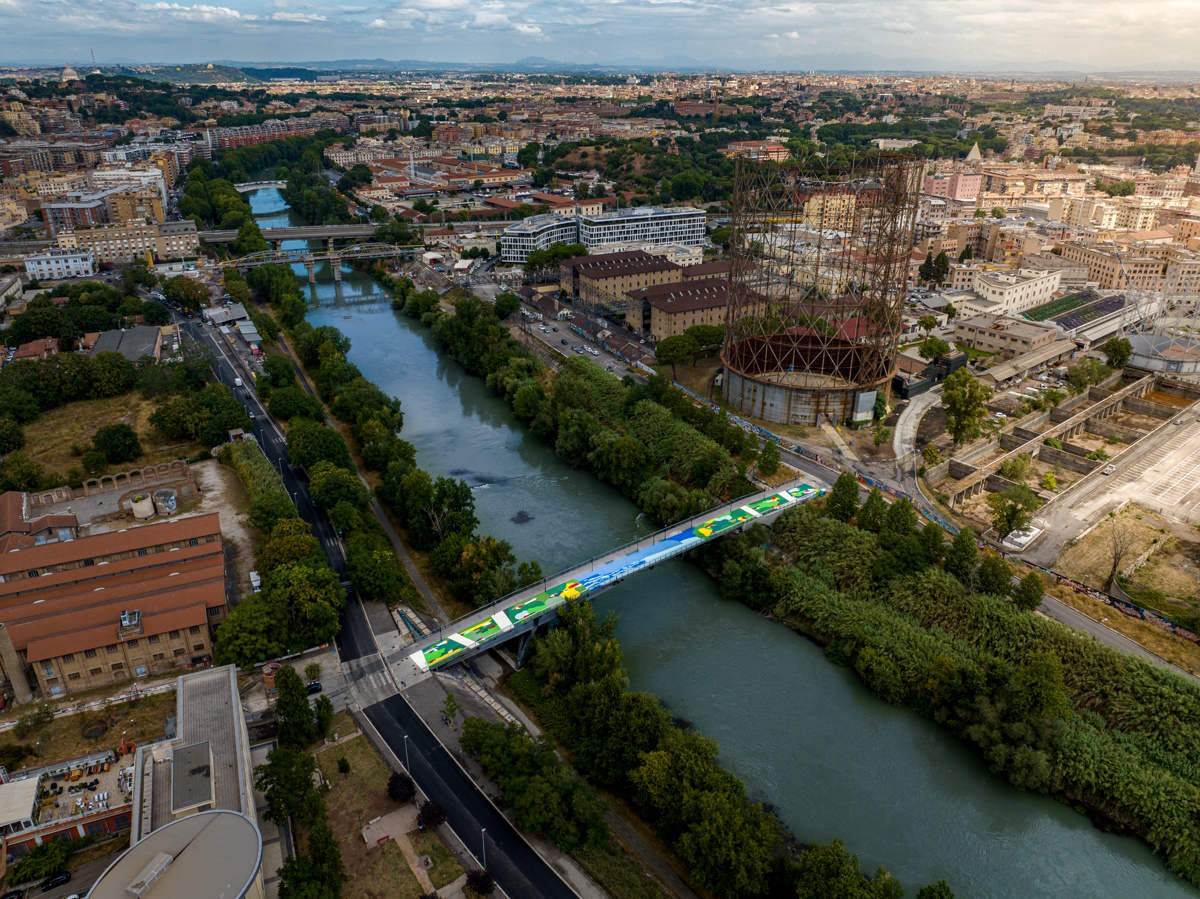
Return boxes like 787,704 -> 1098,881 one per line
376,270 -> 758,525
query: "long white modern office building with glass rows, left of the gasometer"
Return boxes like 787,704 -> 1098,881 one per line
500,206 -> 704,265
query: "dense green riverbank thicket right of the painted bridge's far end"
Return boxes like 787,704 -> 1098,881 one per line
698,475 -> 1200,883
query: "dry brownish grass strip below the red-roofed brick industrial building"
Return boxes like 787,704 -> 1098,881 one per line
0,690 -> 175,773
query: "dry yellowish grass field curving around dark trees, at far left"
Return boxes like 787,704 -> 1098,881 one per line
24,390 -> 202,475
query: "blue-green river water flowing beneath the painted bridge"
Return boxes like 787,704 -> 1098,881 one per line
250,190 -> 1200,899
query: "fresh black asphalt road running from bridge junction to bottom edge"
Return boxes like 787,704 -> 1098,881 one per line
364,695 -> 576,899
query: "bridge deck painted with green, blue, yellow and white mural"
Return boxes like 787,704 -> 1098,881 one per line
409,484 -> 824,671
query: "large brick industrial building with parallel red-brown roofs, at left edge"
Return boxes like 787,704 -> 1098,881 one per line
0,513 -> 228,702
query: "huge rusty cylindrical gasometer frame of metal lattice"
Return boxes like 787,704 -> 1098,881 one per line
722,155 -> 924,424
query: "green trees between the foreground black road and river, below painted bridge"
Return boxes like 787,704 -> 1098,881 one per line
501,592 -> 953,899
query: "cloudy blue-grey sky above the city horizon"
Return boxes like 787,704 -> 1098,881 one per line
0,0 -> 1200,71
